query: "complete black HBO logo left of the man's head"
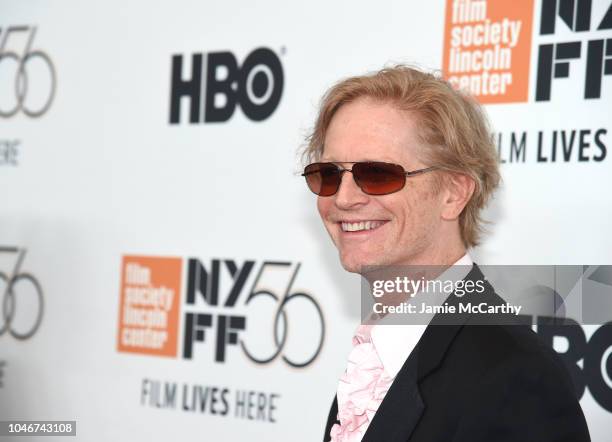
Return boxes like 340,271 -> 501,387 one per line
170,48 -> 283,124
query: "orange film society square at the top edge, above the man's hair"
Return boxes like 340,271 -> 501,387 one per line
442,0 -> 533,103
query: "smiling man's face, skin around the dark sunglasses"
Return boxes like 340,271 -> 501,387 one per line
317,98 -> 444,272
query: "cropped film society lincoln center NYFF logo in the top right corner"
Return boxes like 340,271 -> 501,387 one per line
443,0 -> 612,104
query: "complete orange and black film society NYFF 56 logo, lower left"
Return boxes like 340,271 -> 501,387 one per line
117,255 -> 325,368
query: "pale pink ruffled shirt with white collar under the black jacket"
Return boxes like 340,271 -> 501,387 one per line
330,254 -> 472,442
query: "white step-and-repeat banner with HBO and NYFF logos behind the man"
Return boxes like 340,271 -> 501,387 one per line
0,0 -> 612,442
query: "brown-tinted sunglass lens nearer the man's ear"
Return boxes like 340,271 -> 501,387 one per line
353,162 -> 406,195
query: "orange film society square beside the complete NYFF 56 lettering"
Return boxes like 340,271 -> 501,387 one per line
117,256 -> 182,357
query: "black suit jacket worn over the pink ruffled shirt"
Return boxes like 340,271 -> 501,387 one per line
324,265 -> 590,442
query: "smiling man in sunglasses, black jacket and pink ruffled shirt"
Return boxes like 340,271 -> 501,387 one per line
304,66 -> 589,442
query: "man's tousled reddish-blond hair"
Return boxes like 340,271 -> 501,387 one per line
303,65 -> 501,247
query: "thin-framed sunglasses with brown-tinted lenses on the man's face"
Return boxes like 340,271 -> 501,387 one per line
302,161 -> 436,196
